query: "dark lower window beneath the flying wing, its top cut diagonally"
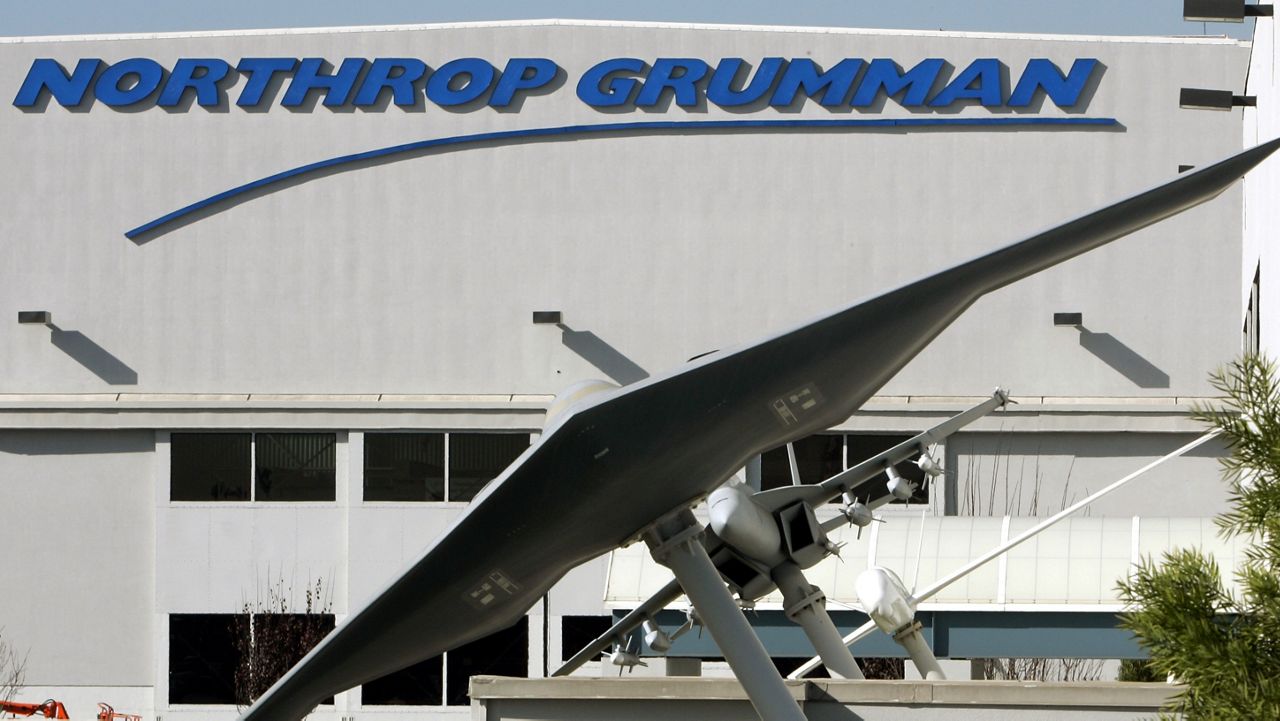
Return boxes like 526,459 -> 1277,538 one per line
361,616 -> 529,706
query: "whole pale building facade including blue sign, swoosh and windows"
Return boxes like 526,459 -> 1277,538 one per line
0,20 -> 1259,721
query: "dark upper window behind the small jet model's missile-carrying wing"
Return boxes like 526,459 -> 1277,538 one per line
760,433 -> 929,503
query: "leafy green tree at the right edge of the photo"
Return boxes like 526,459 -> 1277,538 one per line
1120,356 -> 1280,721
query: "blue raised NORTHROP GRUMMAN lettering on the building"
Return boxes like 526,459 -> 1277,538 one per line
13,58 -> 1098,110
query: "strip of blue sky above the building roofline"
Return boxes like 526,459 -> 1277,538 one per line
0,0 -> 1253,38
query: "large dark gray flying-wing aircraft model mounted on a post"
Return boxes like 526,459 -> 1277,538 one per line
242,141 -> 1280,721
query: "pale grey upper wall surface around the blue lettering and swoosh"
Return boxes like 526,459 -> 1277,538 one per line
0,22 -> 1248,396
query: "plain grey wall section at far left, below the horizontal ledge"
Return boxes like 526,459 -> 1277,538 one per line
0,430 -> 156,686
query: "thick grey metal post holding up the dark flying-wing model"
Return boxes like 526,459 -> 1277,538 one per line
644,508 -> 805,721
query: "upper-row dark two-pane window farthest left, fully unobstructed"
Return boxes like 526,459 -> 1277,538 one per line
169,433 -> 337,501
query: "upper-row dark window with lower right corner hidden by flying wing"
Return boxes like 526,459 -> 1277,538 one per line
365,433 -> 529,502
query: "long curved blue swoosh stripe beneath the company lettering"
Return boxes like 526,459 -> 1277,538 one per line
124,117 -> 1119,239
